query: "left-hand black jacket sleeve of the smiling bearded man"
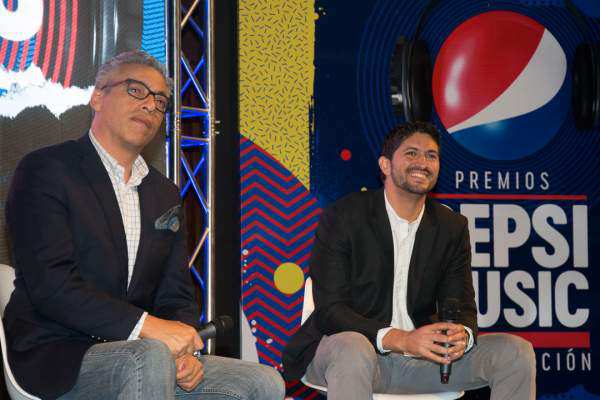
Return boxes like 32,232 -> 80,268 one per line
310,206 -> 387,348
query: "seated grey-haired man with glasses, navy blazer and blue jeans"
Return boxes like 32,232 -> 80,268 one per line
4,51 -> 284,400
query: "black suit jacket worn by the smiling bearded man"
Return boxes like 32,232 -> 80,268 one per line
282,189 -> 477,379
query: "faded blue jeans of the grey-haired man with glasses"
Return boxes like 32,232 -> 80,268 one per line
60,340 -> 285,400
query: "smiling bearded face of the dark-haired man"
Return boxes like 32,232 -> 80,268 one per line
379,132 -> 440,195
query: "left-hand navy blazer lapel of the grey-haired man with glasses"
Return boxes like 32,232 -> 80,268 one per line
79,134 -> 127,293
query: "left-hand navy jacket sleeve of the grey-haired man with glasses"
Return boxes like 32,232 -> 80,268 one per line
6,153 -> 143,340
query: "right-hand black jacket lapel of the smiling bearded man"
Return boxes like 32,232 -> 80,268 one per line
406,201 -> 437,316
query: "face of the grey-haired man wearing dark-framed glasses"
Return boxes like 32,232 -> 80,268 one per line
90,64 -> 169,153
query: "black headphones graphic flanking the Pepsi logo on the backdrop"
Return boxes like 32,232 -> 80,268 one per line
390,0 -> 600,130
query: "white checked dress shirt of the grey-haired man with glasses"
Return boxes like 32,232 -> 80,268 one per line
89,130 -> 149,340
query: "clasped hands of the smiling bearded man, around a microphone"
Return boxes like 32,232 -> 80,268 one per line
382,322 -> 467,364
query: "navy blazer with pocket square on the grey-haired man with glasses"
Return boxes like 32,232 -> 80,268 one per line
4,135 -> 198,398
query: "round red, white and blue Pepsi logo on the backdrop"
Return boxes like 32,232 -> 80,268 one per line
432,11 -> 571,160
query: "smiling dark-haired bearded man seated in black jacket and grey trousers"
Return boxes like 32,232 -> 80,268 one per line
283,122 -> 535,400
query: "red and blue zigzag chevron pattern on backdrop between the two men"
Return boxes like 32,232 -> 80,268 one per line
240,136 -> 321,399
